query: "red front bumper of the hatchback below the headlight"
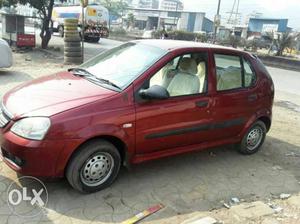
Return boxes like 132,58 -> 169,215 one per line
0,129 -> 78,177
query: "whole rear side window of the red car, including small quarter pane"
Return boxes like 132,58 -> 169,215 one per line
215,54 -> 256,91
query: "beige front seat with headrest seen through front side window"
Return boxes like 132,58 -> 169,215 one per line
167,58 -> 200,96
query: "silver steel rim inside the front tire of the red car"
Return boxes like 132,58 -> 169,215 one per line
80,152 -> 114,187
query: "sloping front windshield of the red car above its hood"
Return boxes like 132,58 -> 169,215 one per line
80,43 -> 167,90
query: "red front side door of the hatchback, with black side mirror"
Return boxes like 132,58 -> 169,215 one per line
135,50 -> 212,154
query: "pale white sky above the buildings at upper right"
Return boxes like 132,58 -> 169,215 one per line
182,0 -> 300,30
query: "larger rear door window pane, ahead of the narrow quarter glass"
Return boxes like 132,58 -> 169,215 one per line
215,54 -> 243,91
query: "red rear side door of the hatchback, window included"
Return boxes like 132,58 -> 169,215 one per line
212,50 -> 259,140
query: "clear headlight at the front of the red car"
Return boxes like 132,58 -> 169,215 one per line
10,117 -> 51,140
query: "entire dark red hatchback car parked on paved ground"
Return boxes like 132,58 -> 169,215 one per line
0,40 -> 274,192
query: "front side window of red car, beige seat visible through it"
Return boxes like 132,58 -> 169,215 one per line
149,53 -> 207,97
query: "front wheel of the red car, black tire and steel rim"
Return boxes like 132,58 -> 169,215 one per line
66,140 -> 121,193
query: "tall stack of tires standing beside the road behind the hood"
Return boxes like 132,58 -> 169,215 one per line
64,19 -> 83,64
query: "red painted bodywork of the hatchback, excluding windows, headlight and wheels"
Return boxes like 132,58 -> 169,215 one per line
0,40 -> 274,177
